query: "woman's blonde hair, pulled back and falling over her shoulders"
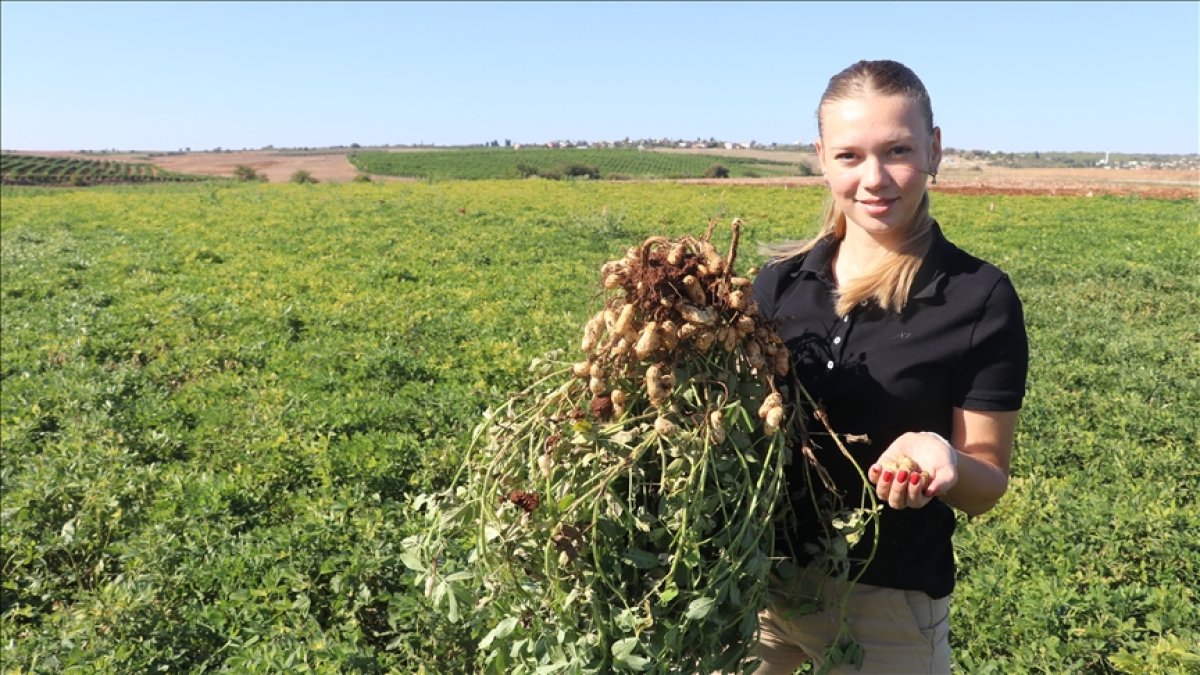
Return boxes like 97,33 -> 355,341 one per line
761,61 -> 934,316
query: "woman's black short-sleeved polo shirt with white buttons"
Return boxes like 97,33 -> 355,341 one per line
754,223 -> 1028,598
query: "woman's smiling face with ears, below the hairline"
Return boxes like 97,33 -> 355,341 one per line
816,94 -> 942,240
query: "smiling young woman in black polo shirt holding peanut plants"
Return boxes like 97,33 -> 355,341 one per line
755,61 -> 1028,674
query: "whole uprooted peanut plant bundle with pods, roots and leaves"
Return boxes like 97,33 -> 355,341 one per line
404,220 -> 859,673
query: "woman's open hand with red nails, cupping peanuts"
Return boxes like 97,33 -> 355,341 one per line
866,431 -> 959,509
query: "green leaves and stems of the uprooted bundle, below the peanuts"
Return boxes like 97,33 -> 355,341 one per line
404,357 -> 806,673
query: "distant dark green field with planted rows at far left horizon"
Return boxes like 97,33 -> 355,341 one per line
0,153 -> 205,186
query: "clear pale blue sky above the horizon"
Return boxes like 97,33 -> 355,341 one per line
0,2 -> 1200,153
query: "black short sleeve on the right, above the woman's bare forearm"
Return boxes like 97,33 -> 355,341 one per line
952,275 -> 1030,411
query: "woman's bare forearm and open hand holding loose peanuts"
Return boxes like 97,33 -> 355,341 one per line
868,408 -> 1016,515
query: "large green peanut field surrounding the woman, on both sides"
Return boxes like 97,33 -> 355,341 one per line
0,181 -> 1200,674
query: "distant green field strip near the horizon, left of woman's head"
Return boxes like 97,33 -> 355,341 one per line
349,147 -> 806,180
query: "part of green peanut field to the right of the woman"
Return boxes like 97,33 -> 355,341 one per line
935,192 -> 1200,673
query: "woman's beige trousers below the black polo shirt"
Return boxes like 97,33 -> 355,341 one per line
755,573 -> 950,675
